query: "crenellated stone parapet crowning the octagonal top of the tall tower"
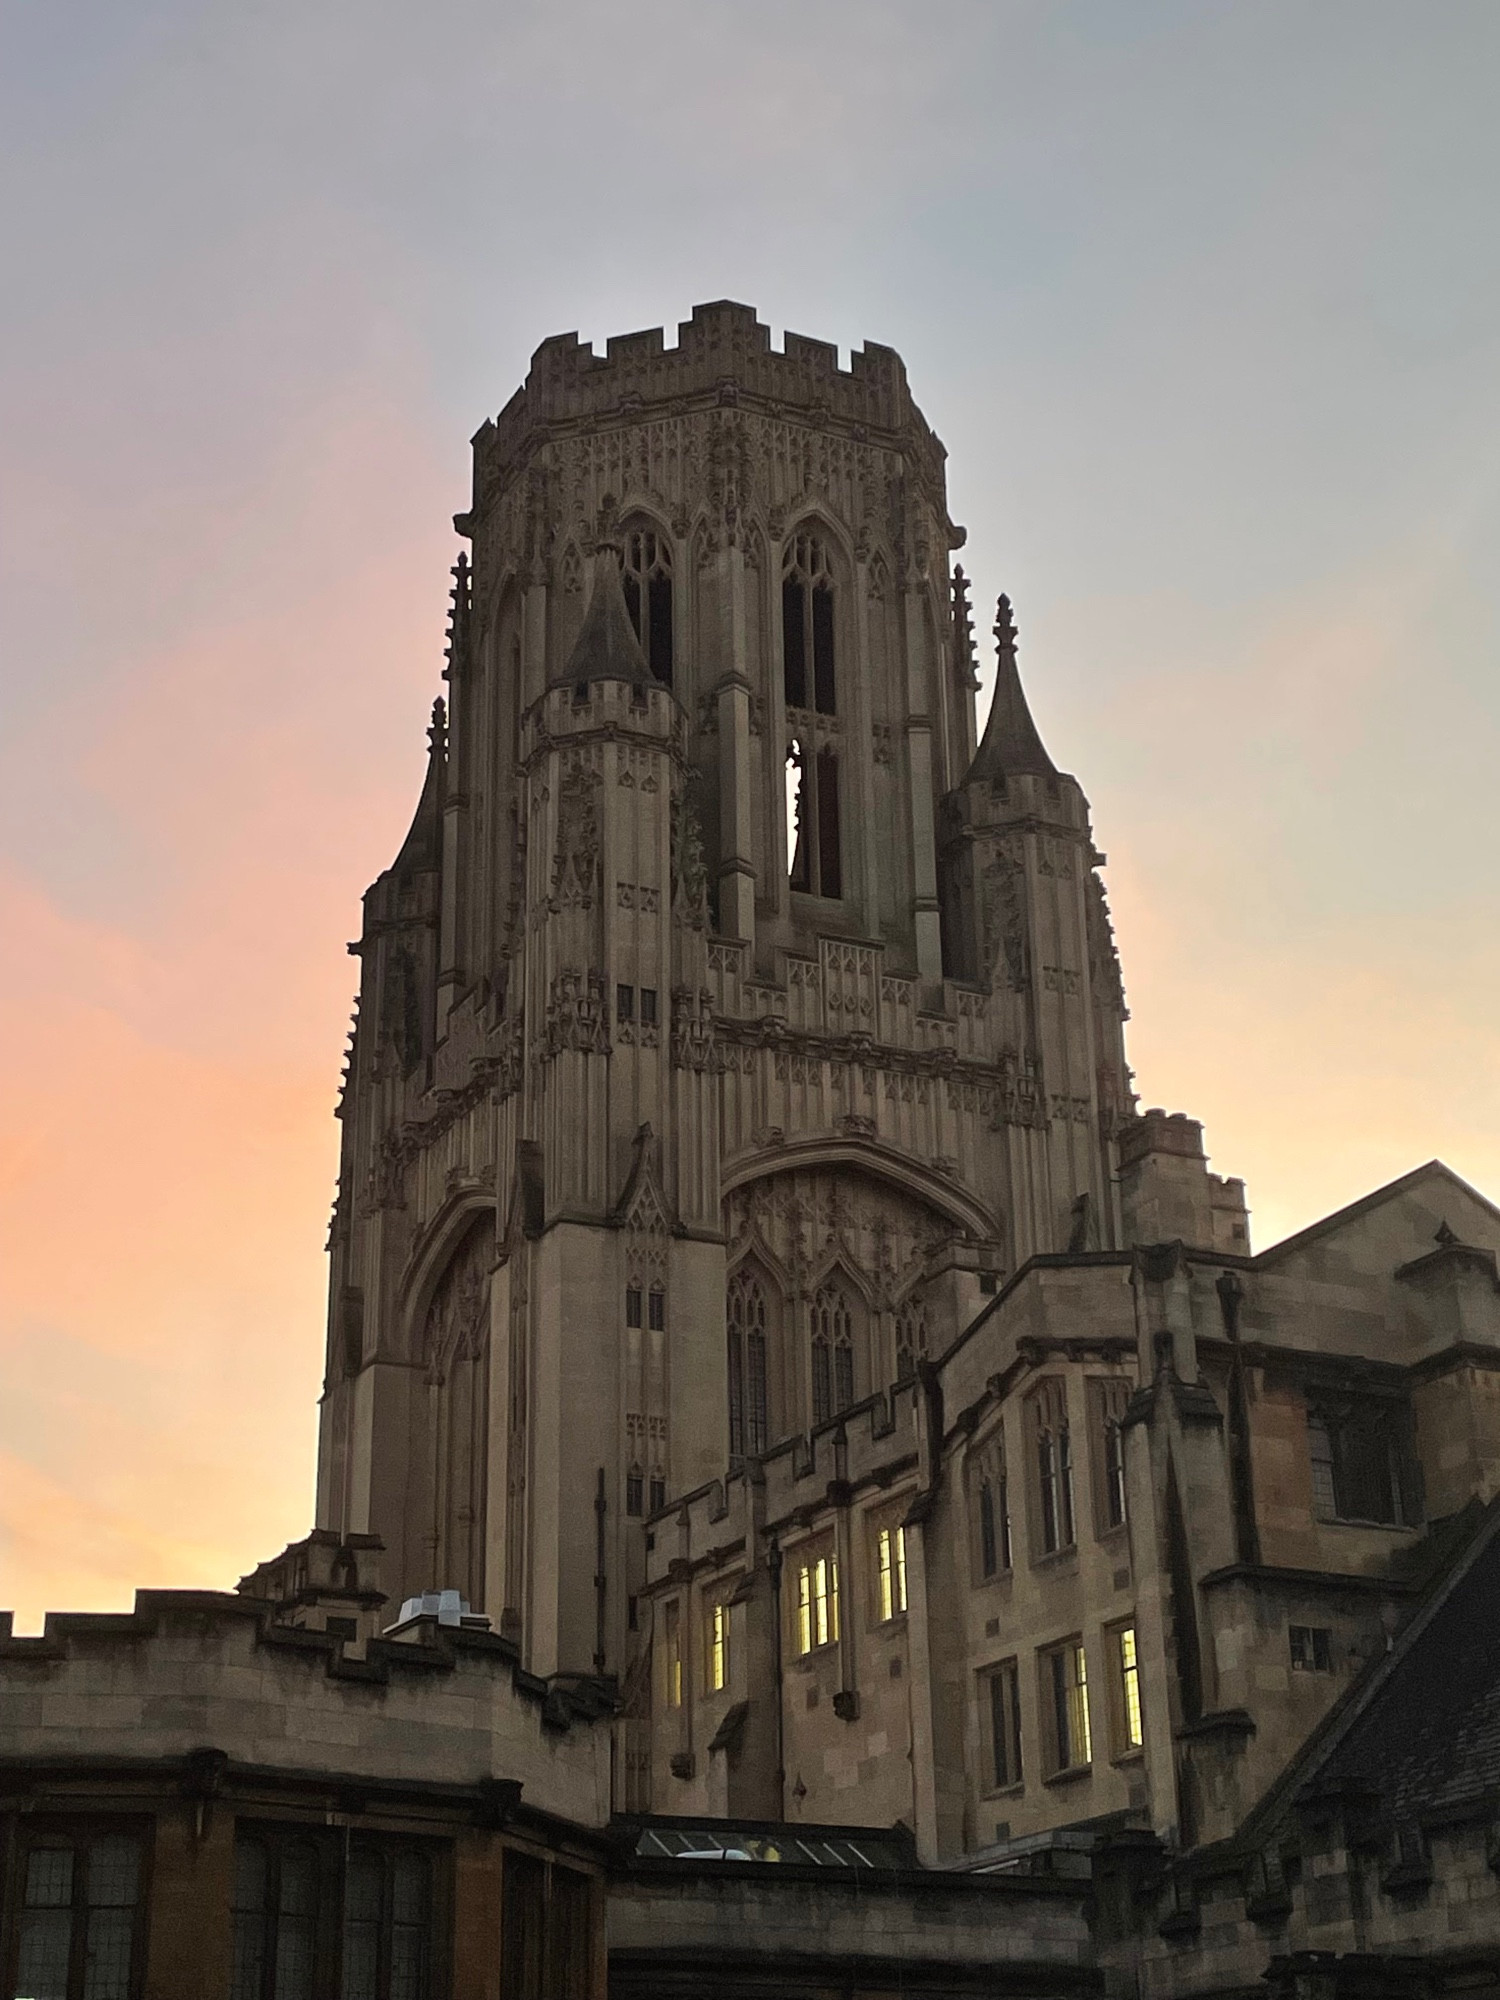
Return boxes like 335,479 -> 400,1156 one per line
474,300 -> 946,496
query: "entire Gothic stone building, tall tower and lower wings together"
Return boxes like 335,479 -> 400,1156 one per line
0,304 -> 1500,2000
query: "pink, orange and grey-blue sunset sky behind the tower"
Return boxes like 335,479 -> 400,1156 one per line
0,0 -> 1500,1628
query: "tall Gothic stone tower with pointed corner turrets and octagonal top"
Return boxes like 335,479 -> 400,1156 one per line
318,304 -> 1130,1680
